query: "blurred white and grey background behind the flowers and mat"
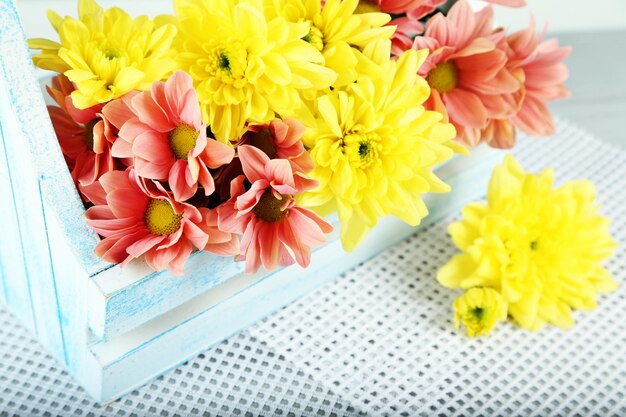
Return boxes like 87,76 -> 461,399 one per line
15,0 -> 626,148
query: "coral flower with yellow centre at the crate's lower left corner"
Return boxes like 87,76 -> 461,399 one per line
86,168 -> 214,275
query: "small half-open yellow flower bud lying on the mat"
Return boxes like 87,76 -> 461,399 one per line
452,287 -> 507,337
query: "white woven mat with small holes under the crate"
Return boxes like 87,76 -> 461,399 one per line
0,118 -> 626,417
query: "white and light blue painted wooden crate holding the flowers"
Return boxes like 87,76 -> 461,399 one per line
0,0 -> 500,402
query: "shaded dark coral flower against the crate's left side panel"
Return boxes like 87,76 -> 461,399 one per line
47,75 -> 117,198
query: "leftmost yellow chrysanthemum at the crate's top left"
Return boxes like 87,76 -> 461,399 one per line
29,0 -> 176,109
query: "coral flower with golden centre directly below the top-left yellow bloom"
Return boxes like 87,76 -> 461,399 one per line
105,71 -> 235,201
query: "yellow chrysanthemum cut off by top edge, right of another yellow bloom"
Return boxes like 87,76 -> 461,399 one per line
263,0 -> 395,88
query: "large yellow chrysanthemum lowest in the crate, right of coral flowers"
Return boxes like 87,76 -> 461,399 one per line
294,41 -> 455,251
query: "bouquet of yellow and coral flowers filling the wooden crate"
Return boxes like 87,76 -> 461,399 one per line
30,0 -> 569,275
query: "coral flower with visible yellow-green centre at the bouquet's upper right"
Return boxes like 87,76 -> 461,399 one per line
413,0 -> 522,146
